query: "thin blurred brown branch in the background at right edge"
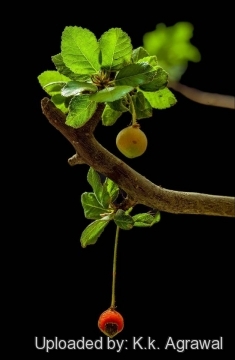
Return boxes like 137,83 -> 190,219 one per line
168,82 -> 235,109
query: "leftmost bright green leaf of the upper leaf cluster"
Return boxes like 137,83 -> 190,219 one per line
38,70 -> 70,96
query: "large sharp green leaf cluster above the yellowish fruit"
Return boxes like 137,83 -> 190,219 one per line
38,26 -> 176,128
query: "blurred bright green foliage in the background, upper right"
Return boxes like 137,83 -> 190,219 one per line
143,22 -> 201,81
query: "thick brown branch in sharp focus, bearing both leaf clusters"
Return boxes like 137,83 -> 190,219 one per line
41,98 -> 235,217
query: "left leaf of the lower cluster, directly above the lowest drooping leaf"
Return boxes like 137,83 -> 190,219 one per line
81,192 -> 109,220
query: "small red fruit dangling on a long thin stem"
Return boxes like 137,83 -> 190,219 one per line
98,308 -> 124,338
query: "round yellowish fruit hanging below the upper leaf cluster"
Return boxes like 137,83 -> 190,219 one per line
116,124 -> 148,159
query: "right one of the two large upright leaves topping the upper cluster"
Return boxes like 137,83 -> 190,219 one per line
99,28 -> 132,71
